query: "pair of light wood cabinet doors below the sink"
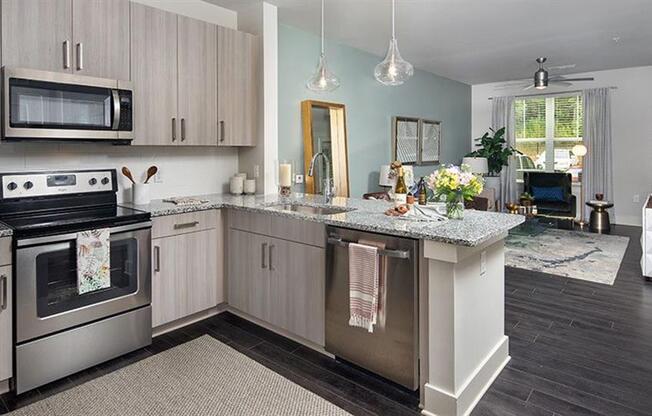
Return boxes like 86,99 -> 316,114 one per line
228,229 -> 326,345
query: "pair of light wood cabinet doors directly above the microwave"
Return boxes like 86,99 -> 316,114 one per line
2,0 -> 129,80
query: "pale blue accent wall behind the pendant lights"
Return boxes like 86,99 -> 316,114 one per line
278,25 -> 471,197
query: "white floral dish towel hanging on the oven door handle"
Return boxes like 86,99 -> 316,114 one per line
77,228 -> 111,295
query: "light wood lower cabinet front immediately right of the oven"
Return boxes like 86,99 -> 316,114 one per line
152,214 -> 224,327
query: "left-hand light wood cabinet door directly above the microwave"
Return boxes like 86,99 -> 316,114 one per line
2,0 -> 73,72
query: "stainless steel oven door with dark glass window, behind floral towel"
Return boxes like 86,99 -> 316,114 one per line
15,222 -> 152,344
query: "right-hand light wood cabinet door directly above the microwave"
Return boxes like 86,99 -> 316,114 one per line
71,0 -> 130,80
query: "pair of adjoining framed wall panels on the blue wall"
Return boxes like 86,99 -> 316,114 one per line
392,117 -> 441,165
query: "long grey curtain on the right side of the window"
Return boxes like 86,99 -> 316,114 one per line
581,88 -> 613,219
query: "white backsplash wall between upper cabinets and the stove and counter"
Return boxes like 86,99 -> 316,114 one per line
0,143 -> 238,202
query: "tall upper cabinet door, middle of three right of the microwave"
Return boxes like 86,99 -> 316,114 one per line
178,16 -> 218,146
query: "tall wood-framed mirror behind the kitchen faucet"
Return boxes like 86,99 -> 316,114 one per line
301,100 -> 349,196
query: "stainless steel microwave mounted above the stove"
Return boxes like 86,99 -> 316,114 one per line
2,67 -> 134,144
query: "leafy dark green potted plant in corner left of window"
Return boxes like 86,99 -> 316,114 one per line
466,127 -> 521,191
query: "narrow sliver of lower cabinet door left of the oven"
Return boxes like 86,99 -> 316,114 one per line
0,260 -> 13,381
